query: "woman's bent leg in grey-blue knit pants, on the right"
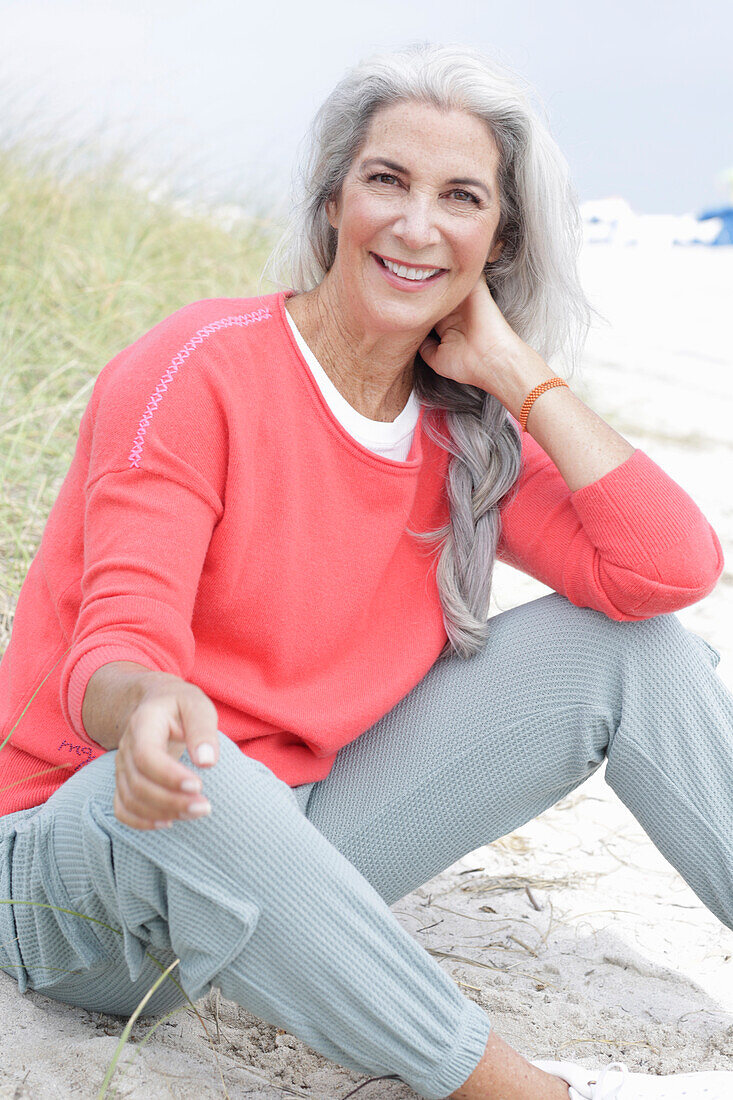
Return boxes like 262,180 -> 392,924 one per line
306,593 -> 733,927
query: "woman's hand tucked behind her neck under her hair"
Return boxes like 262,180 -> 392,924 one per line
419,275 -> 551,411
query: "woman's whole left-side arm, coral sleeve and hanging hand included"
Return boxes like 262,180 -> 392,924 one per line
61,311 -> 234,828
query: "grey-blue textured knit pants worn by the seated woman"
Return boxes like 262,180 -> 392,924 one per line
0,593 -> 733,1100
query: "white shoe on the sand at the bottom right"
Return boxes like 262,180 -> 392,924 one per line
532,1062 -> 733,1100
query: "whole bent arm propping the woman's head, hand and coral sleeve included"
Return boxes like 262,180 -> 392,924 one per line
420,279 -> 724,619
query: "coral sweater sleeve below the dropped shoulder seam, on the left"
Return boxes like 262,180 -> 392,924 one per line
61,459 -> 219,744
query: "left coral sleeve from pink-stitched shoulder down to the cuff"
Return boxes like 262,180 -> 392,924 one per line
61,310 -> 227,748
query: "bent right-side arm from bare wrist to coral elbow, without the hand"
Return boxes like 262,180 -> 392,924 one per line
503,352 -> 724,619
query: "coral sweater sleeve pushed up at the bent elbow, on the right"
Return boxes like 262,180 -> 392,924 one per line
497,432 -> 724,622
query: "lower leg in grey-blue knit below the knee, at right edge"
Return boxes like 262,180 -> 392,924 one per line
605,615 -> 733,928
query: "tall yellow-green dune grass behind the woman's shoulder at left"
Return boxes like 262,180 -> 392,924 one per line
0,127 -> 278,652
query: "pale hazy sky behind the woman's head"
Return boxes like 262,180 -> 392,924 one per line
0,0 -> 733,215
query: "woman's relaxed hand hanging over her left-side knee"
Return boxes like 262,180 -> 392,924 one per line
114,672 -> 219,829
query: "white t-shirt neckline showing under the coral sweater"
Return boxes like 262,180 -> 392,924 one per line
280,309 -> 420,462
